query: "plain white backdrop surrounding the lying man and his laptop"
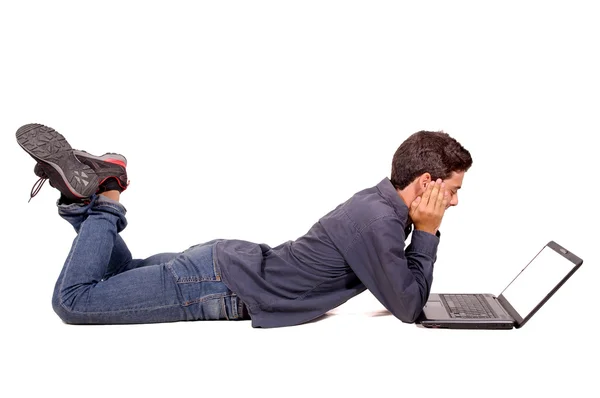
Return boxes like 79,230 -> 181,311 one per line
0,0 -> 600,397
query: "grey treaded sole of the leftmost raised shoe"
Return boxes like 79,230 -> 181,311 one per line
16,124 -> 98,200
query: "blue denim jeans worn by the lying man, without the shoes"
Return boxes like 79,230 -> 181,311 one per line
52,195 -> 250,324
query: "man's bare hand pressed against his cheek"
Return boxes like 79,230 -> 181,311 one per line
408,178 -> 450,235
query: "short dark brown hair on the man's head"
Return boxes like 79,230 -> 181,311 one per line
391,131 -> 473,189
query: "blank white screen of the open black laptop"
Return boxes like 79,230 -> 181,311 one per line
501,246 -> 576,319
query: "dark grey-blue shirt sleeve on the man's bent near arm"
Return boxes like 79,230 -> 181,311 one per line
347,217 -> 439,323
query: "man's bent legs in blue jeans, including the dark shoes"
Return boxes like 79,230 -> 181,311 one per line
17,124 -> 248,324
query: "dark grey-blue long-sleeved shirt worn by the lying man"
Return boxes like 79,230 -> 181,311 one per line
214,178 -> 439,327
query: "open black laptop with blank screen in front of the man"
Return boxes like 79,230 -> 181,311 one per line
416,241 -> 583,329
